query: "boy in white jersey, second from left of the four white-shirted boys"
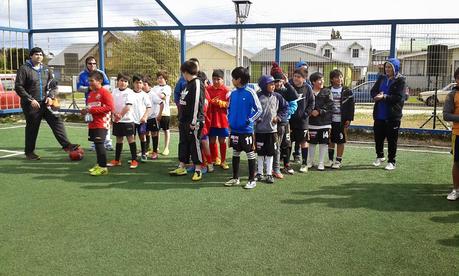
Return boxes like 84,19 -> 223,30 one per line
132,74 -> 151,162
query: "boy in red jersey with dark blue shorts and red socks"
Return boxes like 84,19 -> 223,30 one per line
207,69 -> 230,170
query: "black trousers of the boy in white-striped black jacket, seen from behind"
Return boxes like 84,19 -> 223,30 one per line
179,123 -> 202,165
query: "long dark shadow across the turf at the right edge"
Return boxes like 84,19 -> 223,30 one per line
281,183 -> 457,212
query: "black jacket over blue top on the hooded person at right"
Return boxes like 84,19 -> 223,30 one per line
371,74 -> 406,121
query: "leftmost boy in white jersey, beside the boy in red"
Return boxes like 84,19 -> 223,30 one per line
107,73 -> 138,169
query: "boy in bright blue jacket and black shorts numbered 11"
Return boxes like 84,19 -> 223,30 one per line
225,67 -> 262,189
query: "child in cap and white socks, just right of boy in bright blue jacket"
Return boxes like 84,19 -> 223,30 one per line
255,75 -> 288,184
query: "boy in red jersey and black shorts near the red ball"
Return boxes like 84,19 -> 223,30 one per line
81,71 -> 114,176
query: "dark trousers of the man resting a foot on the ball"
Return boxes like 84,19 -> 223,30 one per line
22,103 -> 70,154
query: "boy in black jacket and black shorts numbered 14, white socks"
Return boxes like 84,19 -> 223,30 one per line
307,72 -> 333,171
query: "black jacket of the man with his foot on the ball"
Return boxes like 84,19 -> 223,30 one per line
14,60 -> 57,105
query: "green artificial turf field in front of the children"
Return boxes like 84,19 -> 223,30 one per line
0,124 -> 459,275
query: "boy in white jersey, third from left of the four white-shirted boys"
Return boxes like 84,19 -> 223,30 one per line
143,76 -> 164,160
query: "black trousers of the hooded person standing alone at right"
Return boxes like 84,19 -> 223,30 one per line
373,120 -> 400,163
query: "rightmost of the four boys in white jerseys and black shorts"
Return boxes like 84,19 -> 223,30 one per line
152,70 -> 172,155
